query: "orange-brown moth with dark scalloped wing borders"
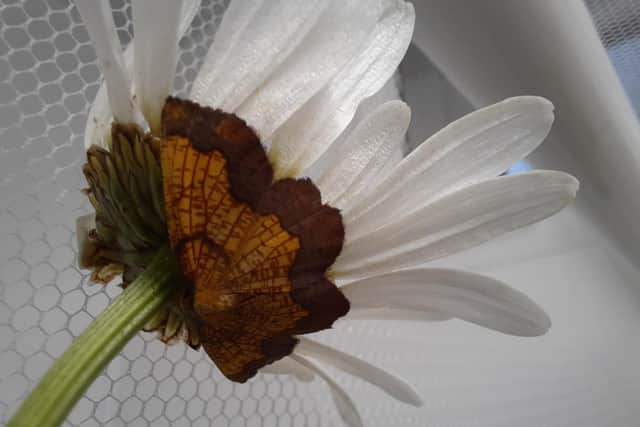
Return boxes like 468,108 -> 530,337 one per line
161,98 -> 349,382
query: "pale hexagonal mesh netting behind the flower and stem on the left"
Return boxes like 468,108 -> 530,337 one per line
0,0 -> 335,426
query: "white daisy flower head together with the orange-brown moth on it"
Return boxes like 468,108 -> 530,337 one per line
10,0 -> 578,426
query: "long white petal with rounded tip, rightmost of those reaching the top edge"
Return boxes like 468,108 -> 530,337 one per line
269,0 -> 414,176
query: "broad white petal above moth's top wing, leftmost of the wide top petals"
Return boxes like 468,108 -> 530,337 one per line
191,0 -> 329,115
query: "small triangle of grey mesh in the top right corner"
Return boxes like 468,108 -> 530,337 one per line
586,0 -> 640,112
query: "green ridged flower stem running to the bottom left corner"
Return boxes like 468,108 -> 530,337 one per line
8,247 -> 178,427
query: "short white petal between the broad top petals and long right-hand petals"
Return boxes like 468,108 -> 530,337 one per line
316,101 -> 411,209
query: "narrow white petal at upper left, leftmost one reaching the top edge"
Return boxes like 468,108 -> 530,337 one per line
76,0 -> 139,127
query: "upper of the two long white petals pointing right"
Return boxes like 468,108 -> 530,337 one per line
343,96 -> 553,237
